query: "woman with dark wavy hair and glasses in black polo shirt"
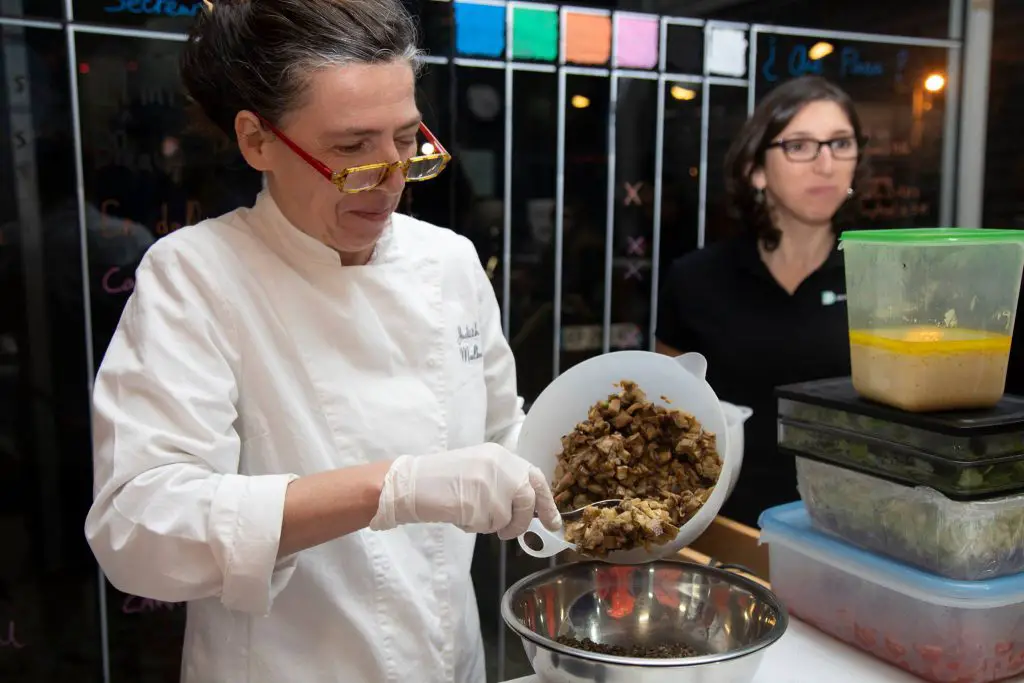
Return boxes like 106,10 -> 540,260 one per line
657,77 -> 863,524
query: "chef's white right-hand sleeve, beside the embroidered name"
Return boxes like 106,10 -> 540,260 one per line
465,240 -> 525,453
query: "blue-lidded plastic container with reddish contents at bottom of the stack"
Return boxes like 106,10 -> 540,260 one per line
761,503 -> 1024,683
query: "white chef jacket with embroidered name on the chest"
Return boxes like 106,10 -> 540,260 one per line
85,191 -> 523,683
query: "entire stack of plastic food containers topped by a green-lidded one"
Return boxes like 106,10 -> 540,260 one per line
762,228 -> 1024,683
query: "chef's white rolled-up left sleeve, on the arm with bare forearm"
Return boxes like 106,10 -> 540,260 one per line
85,236 -> 296,614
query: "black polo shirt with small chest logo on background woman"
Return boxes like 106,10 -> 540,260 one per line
657,239 -> 850,524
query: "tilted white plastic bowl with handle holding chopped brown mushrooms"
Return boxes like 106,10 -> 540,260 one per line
518,351 -> 739,564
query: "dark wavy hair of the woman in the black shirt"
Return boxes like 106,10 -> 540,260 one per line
725,76 -> 867,251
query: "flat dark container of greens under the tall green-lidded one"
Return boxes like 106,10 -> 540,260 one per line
776,379 -> 1024,500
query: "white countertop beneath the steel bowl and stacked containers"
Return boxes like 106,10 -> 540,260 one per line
501,618 -> 1024,683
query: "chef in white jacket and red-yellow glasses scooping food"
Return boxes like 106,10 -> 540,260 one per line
85,0 -> 560,683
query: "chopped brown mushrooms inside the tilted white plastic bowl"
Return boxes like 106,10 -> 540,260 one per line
553,380 -> 722,557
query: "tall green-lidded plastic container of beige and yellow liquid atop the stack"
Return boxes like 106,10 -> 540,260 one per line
842,228 -> 1024,413
